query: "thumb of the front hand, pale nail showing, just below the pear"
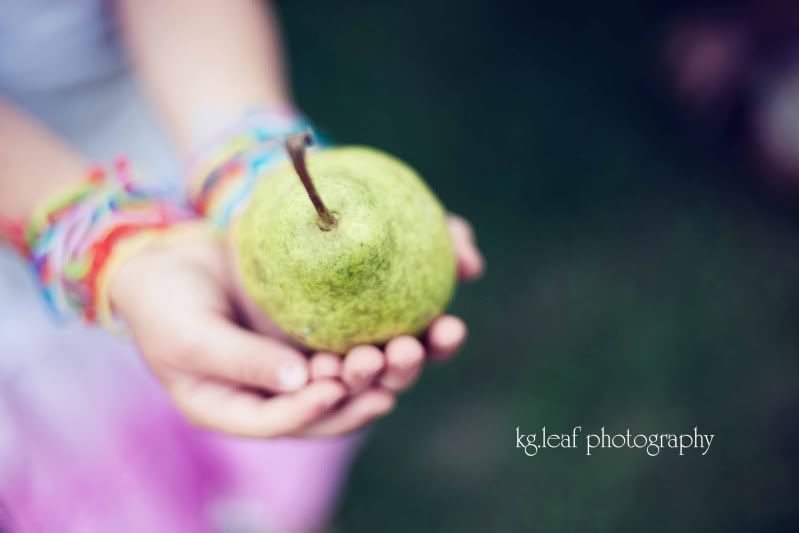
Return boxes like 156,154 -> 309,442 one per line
171,313 -> 310,392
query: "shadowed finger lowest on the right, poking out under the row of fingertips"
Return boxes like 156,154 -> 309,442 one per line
297,389 -> 396,437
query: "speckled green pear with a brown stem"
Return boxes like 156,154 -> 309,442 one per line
233,133 -> 455,353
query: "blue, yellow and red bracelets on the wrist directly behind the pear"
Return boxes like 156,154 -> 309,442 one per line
188,109 -> 324,229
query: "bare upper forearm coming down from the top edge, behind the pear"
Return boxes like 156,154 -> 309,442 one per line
120,0 -> 290,155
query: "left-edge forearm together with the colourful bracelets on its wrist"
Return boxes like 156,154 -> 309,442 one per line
0,101 -> 192,326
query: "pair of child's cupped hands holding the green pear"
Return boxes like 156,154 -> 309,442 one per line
110,210 -> 483,438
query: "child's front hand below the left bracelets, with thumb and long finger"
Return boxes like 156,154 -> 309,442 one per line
110,224 -> 354,437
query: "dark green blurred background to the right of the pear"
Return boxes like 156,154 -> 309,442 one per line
278,0 -> 799,532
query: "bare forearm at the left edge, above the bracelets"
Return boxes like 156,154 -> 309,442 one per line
0,99 -> 89,220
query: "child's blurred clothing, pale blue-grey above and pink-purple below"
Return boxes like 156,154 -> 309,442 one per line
0,0 -> 356,533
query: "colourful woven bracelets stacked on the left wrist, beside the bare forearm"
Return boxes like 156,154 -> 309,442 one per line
19,160 -> 191,326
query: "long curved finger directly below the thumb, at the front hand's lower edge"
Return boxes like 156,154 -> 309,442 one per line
169,377 -> 347,438
